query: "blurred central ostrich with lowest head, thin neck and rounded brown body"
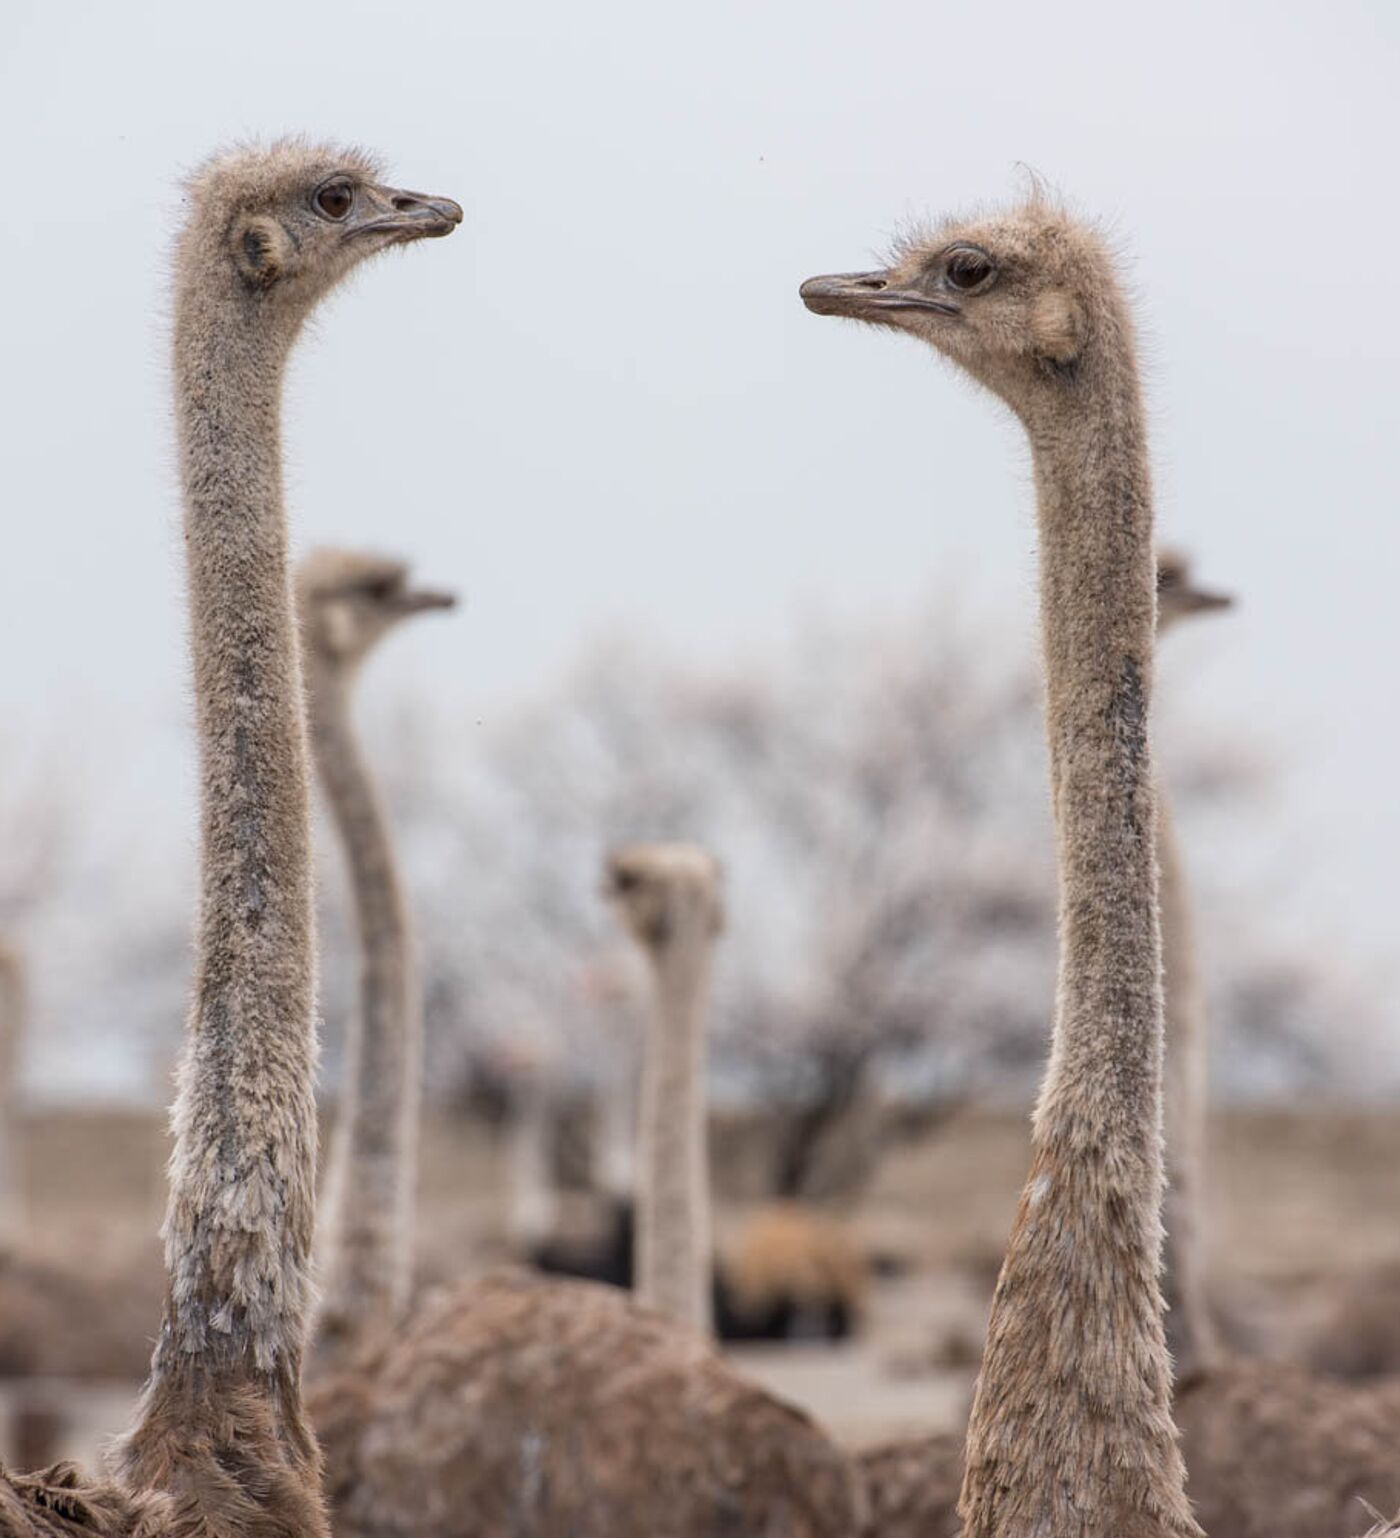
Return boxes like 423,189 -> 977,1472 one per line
311,846 -> 860,1538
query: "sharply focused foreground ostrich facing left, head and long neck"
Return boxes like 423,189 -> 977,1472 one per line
802,198 -> 1198,1538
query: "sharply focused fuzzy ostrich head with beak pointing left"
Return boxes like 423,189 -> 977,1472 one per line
800,197 -> 1126,420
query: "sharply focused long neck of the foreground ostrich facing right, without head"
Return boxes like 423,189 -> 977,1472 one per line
118,278 -> 325,1533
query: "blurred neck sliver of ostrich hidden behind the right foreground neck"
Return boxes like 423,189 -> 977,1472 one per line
1157,778 -> 1220,1386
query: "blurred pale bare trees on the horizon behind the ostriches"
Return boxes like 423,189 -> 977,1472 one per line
10,594 -> 1400,1197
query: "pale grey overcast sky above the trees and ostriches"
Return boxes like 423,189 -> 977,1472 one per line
0,0 -> 1400,954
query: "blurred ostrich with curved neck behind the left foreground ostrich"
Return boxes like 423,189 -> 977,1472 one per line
297,551 -> 455,1367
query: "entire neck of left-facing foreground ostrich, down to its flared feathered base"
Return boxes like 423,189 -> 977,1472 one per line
960,336 -> 1197,1538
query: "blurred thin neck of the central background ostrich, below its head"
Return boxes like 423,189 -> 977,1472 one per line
637,924 -> 714,1333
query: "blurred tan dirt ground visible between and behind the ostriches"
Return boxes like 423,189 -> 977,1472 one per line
0,1110 -> 1400,1461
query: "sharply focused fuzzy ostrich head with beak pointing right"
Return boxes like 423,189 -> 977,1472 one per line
177,138 -> 462,318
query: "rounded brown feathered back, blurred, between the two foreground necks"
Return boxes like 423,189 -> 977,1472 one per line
311,1273 -> 860,1538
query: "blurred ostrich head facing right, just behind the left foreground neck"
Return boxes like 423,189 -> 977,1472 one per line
297,551 -> 457,667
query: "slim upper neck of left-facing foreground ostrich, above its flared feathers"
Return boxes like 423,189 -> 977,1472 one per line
1032,373 -> 1162,1144
